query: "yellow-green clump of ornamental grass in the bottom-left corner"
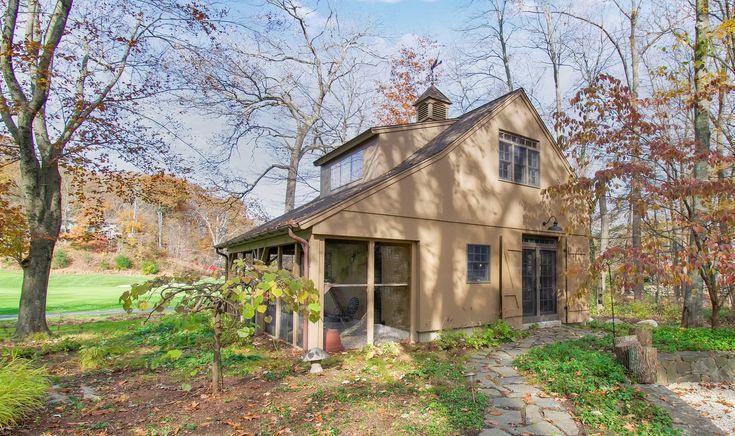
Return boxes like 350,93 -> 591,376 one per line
0,358 -> 49,430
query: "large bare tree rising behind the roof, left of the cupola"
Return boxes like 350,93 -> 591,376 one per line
180,0 -> 374,211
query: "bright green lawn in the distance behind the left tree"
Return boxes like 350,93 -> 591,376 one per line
0,271 -> 150,315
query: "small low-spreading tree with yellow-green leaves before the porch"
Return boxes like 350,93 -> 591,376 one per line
120,260 -> 321,394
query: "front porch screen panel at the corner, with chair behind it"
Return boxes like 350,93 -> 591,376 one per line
323,239 -> 368,352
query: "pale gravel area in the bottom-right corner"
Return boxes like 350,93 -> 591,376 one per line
668,383 -> 735,434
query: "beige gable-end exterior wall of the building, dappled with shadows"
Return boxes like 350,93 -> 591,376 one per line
312,97 -> 587,332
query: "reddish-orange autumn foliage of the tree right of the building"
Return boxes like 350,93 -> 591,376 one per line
549,75 -> 735,324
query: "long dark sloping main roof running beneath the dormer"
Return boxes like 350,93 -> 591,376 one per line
215,88 -> 524,248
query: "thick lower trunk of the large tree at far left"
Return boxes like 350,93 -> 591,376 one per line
15,145 -> 61,338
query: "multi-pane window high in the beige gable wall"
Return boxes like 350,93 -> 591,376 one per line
498,132 -> 541,186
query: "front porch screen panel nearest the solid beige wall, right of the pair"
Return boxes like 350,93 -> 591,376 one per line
373,242 -> 411,344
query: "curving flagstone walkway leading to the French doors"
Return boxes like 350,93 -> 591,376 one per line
466,326 -> 590,436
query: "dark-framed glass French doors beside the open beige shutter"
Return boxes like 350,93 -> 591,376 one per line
521,236 -> 558,323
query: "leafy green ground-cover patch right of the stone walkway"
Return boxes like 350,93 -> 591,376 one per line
516,336 -> 678,435
